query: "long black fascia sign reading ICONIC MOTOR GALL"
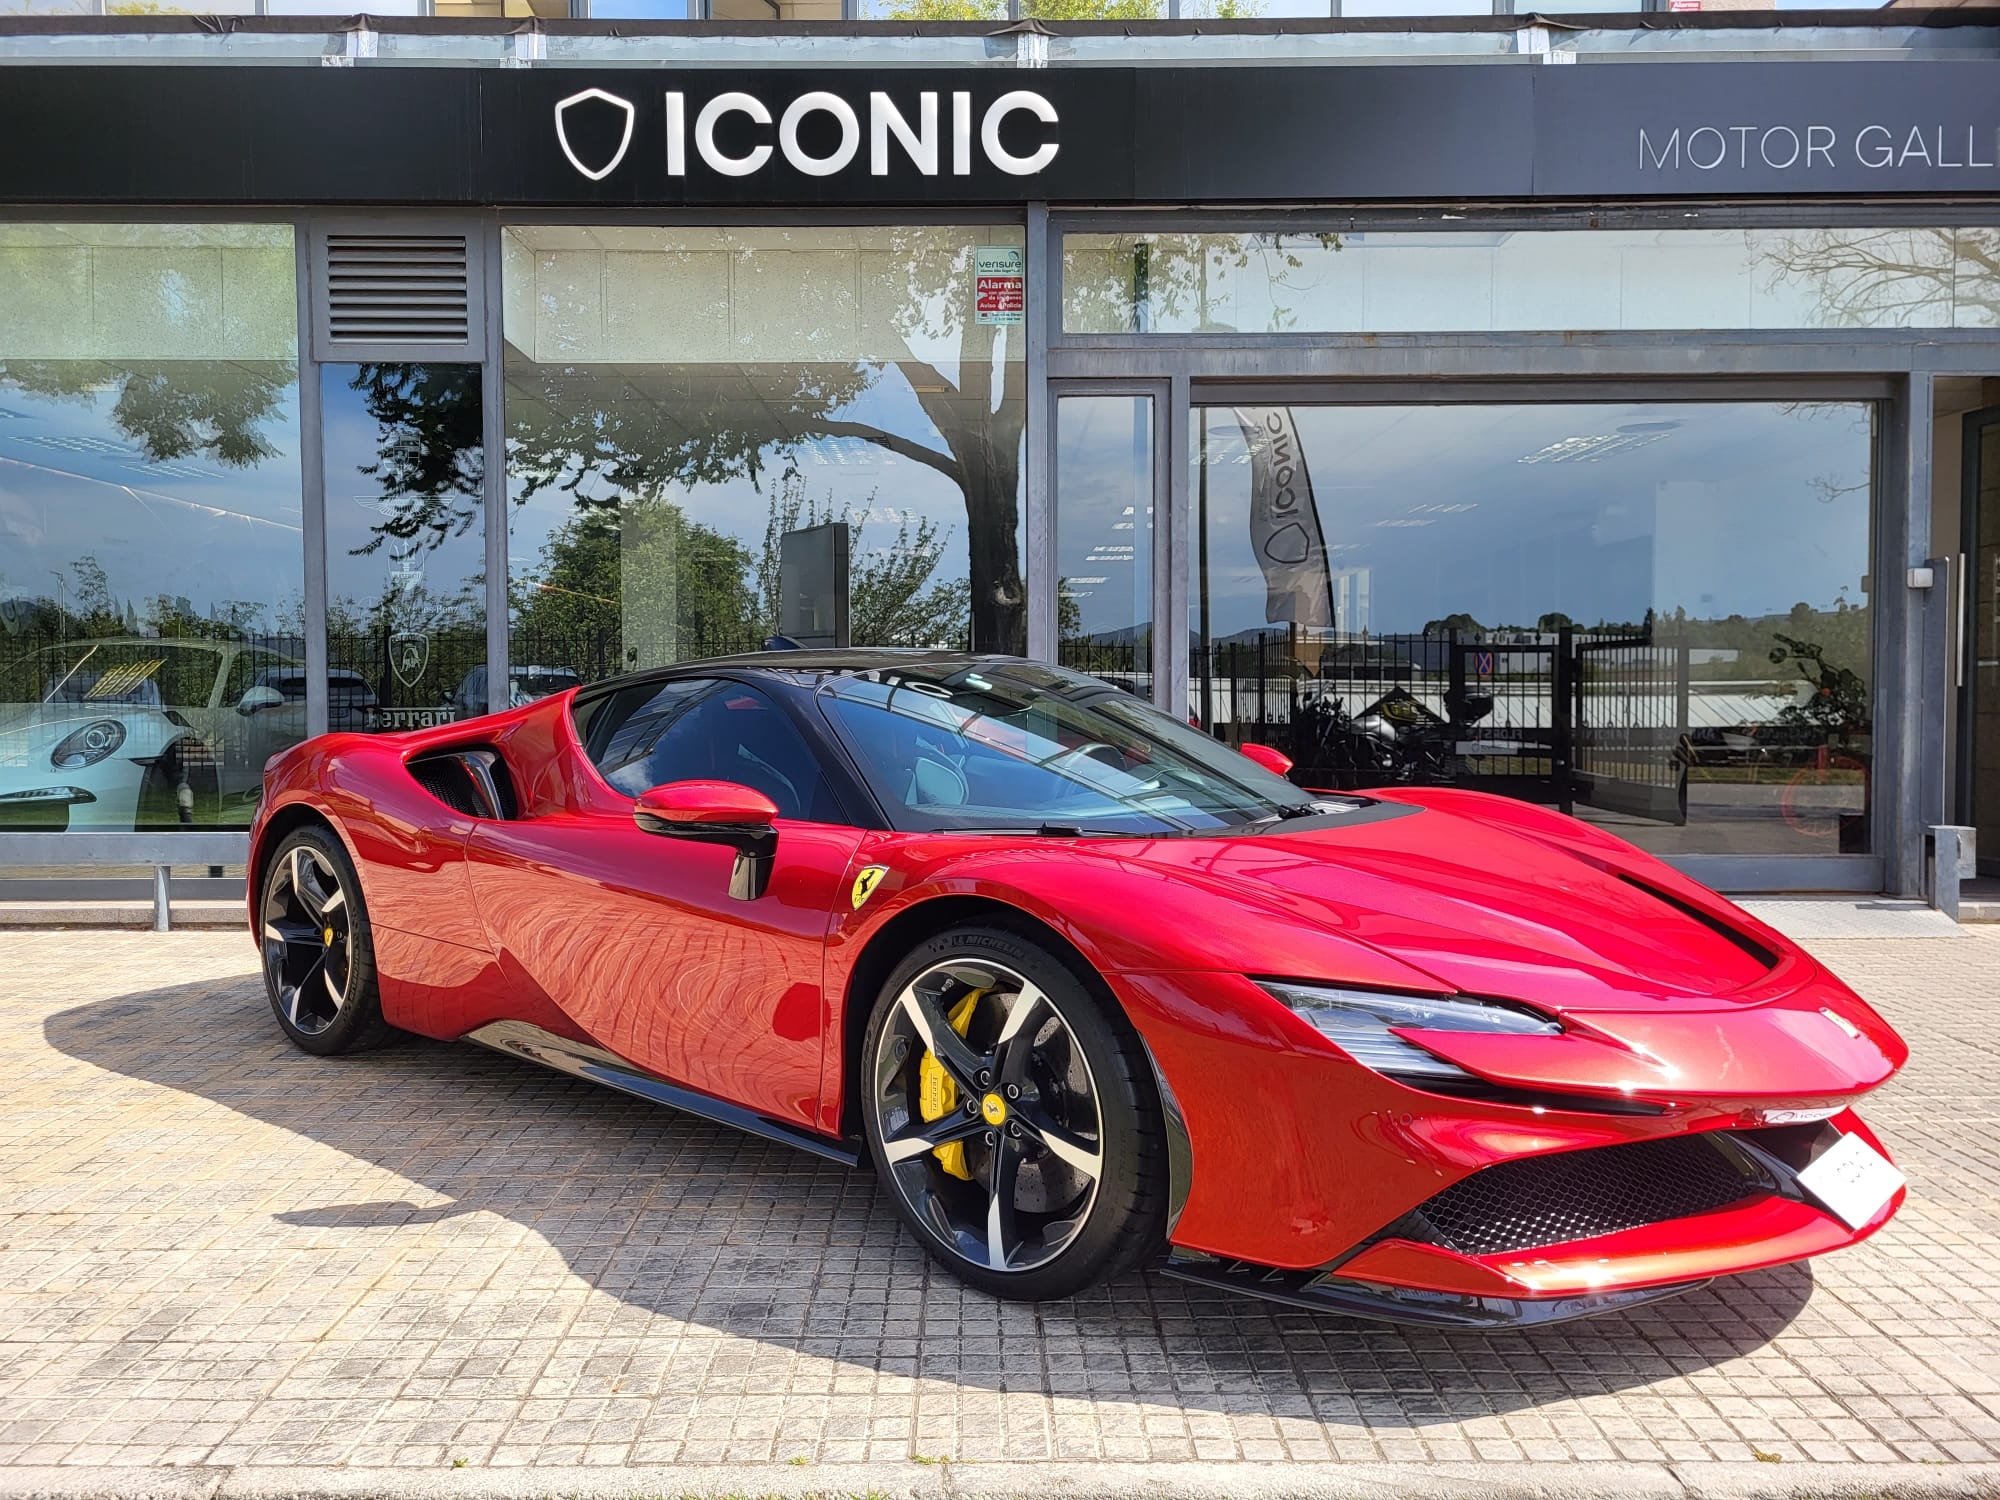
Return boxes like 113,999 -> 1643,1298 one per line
0,62 -> 2000,208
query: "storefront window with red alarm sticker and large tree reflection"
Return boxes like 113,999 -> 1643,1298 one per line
504,226 -> 1026,696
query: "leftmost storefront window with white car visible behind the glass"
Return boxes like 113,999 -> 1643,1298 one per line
0,224 -> 306,832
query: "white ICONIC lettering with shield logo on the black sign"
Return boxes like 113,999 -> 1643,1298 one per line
616,88 -> 1064,182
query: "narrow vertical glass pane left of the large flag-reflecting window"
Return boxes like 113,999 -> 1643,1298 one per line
1052,382 -> 1166,704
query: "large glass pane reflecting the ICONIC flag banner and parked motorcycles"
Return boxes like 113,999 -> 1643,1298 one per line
1188,402 -> 1874,854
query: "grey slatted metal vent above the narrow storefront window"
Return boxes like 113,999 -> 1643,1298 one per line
326,234 -> 472,346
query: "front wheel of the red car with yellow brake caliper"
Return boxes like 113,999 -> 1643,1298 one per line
860,926 -> 1166,1300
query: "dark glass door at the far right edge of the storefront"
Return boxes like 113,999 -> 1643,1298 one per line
1958,406 -> 2000,874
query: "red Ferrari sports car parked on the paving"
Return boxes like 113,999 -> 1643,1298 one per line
250,650 -> 1908,1326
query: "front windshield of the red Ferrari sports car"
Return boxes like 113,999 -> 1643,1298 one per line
818,662 -> 1318,834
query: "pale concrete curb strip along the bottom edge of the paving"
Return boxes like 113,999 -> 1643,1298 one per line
0,1462 -> 2000,1500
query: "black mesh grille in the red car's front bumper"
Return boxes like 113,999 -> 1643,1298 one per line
1416,1136 -> 1760,1256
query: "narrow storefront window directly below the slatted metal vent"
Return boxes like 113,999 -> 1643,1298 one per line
320,364 -> 492,732
